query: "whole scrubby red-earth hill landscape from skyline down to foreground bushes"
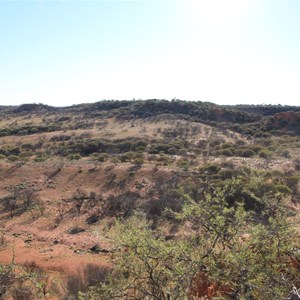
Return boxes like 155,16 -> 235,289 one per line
0,99 -> 300,299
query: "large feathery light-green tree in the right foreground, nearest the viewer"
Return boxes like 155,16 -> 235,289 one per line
81,180 -> 300,300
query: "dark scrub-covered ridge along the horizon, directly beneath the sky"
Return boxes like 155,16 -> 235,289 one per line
0,99 -> 300,137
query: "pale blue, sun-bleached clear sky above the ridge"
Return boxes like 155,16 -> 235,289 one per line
0,0 -> 300,106
